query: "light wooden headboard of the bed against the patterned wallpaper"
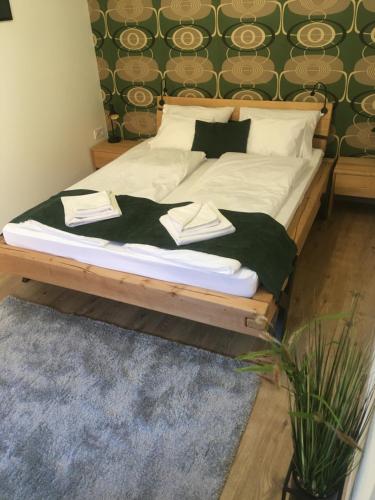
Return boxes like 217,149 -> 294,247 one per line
156,96 -> 333,151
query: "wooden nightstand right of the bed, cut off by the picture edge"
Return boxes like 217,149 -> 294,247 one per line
333,156 -> 375,198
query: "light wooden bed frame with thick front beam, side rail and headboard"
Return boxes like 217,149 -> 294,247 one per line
0,97 -> 333,337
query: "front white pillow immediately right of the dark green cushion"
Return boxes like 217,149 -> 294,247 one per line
246,117 -> 304,157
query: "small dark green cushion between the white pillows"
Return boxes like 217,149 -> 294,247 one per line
191,120 -> 251,158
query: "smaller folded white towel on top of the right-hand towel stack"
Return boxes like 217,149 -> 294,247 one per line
168,202 -> 219,231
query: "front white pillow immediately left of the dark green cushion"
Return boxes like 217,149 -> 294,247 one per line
149,115 -> 206,151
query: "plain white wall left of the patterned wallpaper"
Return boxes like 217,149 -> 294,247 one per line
0,0 -> 105,231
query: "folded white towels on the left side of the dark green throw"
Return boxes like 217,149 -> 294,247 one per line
61,191 -> 121,227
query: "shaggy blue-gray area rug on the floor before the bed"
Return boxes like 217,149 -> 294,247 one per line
0,298 -> 258,500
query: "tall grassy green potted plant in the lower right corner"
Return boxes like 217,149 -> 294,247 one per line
239,296 -> 374,500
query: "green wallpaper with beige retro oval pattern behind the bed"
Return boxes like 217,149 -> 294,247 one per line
88,0 -> 375,155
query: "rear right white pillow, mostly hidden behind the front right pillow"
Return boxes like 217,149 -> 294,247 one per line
240,108 -> 321,158
